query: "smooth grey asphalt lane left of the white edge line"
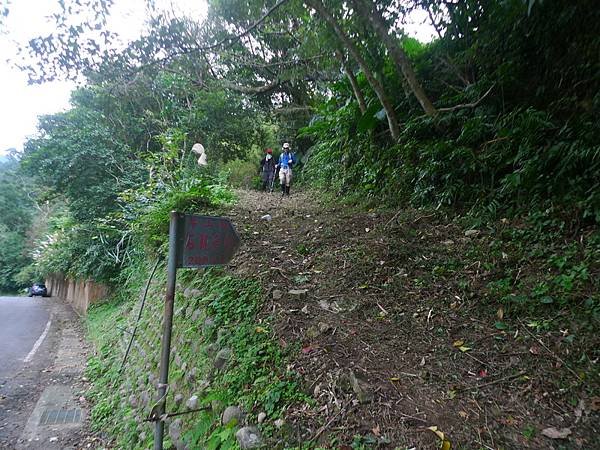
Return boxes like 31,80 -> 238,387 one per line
0,297 -> 50,386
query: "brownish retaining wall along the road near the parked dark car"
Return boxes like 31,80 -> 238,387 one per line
46,274 -> 109,314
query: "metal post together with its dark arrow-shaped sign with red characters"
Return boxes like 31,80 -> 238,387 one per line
154,211 -> 240,450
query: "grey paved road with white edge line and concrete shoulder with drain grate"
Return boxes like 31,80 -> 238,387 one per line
0,297 -> 95,450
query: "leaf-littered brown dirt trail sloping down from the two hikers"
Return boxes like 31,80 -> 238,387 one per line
225,191 -> 600,449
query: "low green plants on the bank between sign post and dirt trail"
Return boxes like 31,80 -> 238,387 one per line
183,271 -> 307,442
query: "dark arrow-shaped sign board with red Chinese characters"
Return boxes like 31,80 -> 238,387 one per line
178,215 -> 240,267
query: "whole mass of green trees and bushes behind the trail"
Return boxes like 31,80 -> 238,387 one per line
2,0 -> 600,288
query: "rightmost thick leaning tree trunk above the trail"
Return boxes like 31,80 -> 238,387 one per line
353,0 -> 438,116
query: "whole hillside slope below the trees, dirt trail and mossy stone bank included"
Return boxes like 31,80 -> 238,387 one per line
90,191 -> 600,449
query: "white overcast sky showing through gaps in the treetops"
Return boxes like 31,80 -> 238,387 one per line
0,0 -> 433,155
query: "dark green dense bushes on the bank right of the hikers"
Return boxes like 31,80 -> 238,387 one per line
302,1 -> 600,223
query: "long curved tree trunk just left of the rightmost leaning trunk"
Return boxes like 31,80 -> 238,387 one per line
305,0 -> 400,141
